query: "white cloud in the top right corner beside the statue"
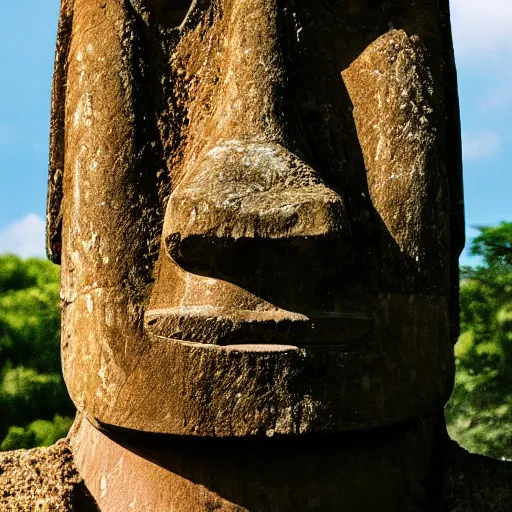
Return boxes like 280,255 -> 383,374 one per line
450,0 -> 512,62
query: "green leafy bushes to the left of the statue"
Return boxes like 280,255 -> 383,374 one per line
0,255 -> 74,450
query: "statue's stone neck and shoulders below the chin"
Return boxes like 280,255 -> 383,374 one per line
0,428 -> 512,512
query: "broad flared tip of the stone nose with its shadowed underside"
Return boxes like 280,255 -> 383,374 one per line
164,141 -> 351,279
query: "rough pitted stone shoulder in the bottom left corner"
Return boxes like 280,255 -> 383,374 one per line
0,439 -> 99,512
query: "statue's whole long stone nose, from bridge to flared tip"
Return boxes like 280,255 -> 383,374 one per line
163,0 -> 351,278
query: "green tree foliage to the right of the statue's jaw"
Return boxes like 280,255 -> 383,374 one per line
446,222 -> 512,459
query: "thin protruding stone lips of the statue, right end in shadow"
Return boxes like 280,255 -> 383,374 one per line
144,306 -> 373,352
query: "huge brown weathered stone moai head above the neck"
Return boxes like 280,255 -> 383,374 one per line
47,0 -> 463,436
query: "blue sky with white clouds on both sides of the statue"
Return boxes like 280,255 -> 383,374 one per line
0,0 -> 512,264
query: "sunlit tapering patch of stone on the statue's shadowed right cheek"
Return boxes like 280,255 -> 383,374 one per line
342,30 -> 449,289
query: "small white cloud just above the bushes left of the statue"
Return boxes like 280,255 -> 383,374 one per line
0,213 -> 45,258
